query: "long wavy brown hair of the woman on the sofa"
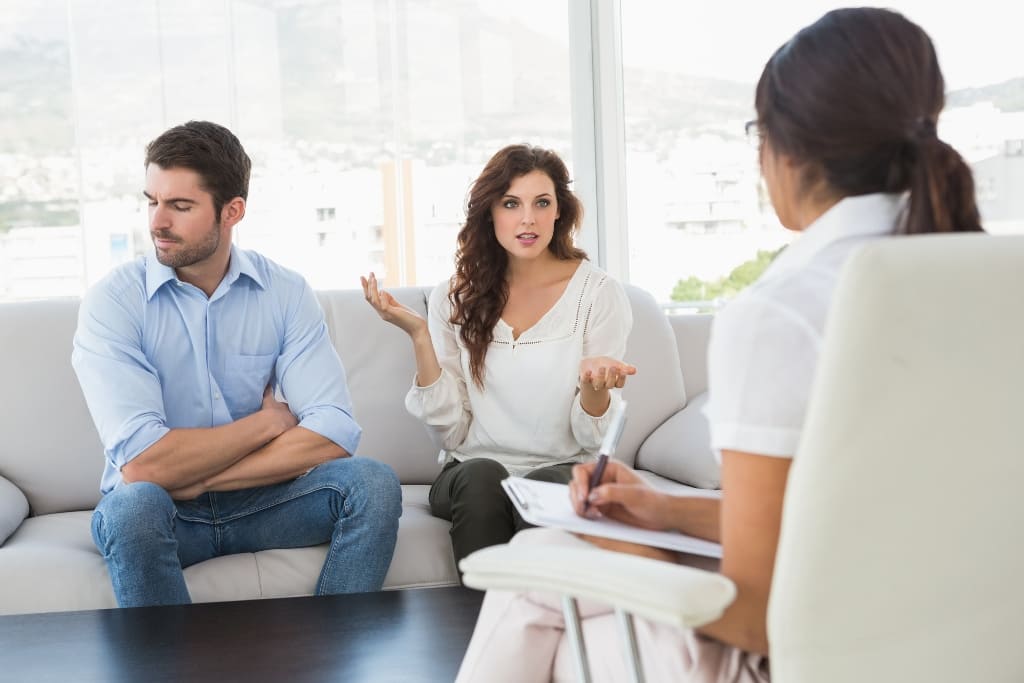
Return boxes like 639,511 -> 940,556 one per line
449,144 -> 587,388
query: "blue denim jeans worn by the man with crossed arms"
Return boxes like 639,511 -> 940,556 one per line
92,458 -> 401,607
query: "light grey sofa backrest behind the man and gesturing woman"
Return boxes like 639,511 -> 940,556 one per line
0,286 -> 686,515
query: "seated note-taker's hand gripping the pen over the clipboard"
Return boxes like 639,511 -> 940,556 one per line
569,460 -> 674,530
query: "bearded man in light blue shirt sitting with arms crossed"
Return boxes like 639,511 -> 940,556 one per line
72,121 -> 401,607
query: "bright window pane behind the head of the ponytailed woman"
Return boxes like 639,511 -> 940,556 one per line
622,0 -> 1024,310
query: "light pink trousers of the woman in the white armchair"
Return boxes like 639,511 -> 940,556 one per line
457,528 -> 769,683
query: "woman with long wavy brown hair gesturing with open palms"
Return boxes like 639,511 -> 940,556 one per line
360,144 -> 636,565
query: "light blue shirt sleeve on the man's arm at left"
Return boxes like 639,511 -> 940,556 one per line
72,282 -> 170,479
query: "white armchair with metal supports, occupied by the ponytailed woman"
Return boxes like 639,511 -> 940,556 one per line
462,234 -> 1024,683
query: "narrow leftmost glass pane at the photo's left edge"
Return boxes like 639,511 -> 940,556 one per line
0,0 -> 82,300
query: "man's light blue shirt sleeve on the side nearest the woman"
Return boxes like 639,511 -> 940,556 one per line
275,281 -> 362,455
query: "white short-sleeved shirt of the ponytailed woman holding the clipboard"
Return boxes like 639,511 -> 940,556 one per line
705,194 -> 905,458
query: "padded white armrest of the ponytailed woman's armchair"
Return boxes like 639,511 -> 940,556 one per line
459,545 -> 736,628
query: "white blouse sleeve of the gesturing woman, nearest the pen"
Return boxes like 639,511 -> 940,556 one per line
569,278 -> 633,451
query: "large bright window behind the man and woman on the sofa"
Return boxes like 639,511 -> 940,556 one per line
0,0 -> 571,300
